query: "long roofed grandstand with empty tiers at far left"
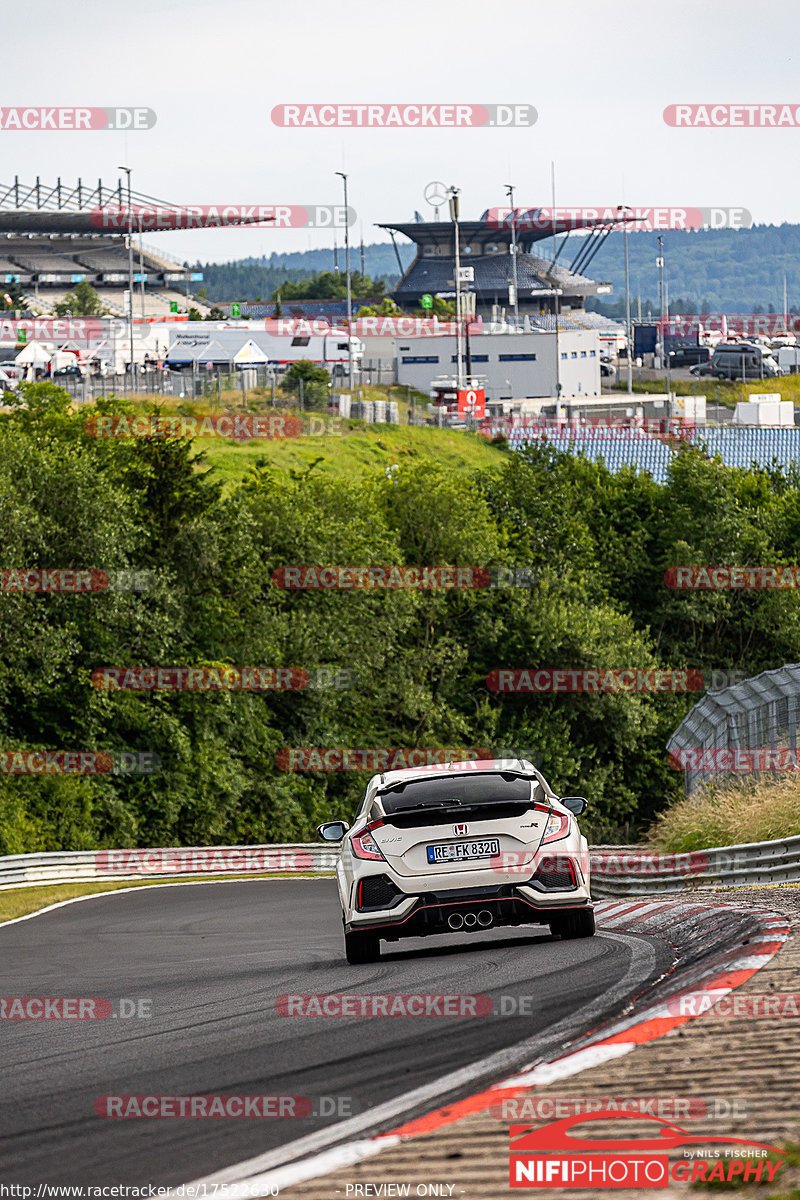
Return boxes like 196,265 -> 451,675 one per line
0,176 -> 210,320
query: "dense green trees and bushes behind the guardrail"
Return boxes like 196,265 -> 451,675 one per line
0,384 -> 800,853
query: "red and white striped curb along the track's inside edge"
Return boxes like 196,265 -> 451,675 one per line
166,900 -> 790,1200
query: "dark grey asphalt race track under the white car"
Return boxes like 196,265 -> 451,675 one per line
0,880 -> 669,1186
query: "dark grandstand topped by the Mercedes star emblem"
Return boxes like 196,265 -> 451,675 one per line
379,212 -> 616,318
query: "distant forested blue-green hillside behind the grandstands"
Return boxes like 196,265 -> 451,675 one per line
194,224 -> 800,316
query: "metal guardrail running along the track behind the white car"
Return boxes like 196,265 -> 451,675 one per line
0,838 -> 800,899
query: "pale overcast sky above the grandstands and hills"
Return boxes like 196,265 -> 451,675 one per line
0,0 -> 800,260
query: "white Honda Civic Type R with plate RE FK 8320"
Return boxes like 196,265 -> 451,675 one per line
318,758 -> 595,964
